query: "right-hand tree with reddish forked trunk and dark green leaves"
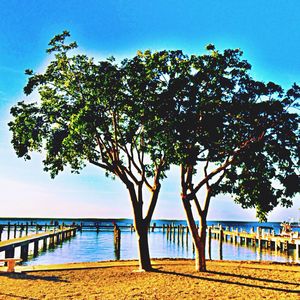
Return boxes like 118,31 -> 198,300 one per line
170,45 -> 300,271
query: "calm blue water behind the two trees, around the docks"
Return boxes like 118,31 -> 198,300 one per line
0,219 -> 300,265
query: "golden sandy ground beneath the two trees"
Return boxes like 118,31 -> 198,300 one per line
0,259 -> 300,300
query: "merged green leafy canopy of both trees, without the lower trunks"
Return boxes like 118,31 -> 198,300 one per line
9,31 -> 300,223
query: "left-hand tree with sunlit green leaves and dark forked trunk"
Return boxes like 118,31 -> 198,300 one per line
9,31 -> 169,271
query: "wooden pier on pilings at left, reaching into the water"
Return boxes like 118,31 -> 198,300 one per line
0,227 -> 76,261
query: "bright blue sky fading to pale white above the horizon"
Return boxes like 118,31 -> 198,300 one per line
0,0 -> 300,221
